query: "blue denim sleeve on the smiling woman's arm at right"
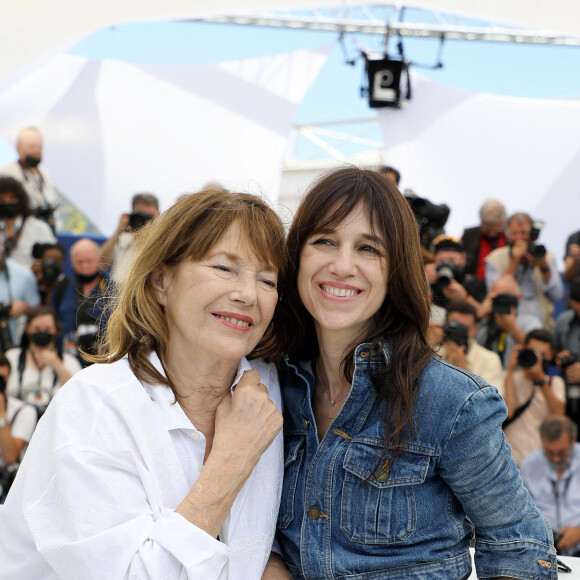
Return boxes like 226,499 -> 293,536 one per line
440,387 -> 557,580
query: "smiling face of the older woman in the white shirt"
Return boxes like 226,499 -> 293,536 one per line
153,222 -> 278,364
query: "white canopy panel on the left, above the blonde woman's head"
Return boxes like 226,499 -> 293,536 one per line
0,48 -> 326,234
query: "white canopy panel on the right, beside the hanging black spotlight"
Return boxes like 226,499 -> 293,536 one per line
379,76 -> 580,262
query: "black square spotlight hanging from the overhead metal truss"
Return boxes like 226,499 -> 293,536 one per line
363,53 -> 411,108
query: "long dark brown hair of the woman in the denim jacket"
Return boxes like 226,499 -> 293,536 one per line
287,166 -> 433,472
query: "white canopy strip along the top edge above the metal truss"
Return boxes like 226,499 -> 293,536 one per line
0,0 -> 580,86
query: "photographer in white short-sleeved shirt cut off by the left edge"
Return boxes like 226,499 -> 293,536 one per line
0,353 -> 37,503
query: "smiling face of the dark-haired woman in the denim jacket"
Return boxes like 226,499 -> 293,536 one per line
298,204 -> 387,341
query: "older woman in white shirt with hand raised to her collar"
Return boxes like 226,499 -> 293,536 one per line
0,190 -> 286,580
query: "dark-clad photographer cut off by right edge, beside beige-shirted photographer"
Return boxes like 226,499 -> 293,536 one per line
554,278 -> 580,424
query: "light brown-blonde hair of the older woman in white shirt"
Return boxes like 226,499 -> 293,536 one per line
86,188 -> 287,388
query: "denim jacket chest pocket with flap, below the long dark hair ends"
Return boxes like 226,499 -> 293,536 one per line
341,438 -> 429,544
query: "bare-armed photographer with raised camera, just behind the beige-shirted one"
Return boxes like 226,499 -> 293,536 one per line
476,276 -> 543,369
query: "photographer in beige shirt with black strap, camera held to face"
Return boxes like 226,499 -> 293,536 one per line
504,330 -> 566,465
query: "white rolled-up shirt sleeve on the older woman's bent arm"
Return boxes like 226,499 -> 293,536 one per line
23,446 -> 229,580
